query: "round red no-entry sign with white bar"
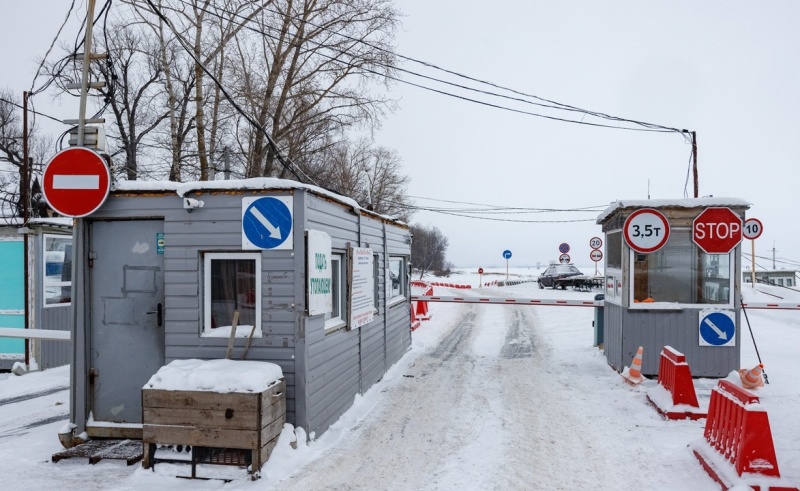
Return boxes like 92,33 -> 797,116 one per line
42,147 -> 111,217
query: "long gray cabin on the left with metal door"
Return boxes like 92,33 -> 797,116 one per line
61,178 -> 411,445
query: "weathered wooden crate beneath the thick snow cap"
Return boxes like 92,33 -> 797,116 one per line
142,379 -> 286,474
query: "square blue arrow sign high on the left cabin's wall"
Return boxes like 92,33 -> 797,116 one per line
242,196 -> 294,249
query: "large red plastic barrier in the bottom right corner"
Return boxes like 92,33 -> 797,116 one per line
692,380 -> 800,491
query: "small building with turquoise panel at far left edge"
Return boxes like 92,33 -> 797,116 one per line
0,218 -> 72,370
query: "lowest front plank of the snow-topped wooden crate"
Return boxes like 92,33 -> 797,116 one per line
142,424 -> 259,449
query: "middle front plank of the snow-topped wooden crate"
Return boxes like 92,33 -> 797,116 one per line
143,407 -> 259,430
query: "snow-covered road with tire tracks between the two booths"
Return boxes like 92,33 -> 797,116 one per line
266,298 -> 715,490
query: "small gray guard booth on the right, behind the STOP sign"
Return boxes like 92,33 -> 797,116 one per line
597,198 -> 750,377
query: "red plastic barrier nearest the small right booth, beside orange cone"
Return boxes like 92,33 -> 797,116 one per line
647,346 -> 706,420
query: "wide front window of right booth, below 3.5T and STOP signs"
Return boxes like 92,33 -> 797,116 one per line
631,230 -> 733,305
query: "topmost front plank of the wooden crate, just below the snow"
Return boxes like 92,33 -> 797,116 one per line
142,389 -> 261,411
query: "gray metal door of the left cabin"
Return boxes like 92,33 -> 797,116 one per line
89,220 -> 164,423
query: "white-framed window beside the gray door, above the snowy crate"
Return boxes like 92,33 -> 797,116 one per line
203,253 -> 261,337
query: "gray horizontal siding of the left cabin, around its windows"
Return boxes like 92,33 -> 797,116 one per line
87,186 -> 411,434
